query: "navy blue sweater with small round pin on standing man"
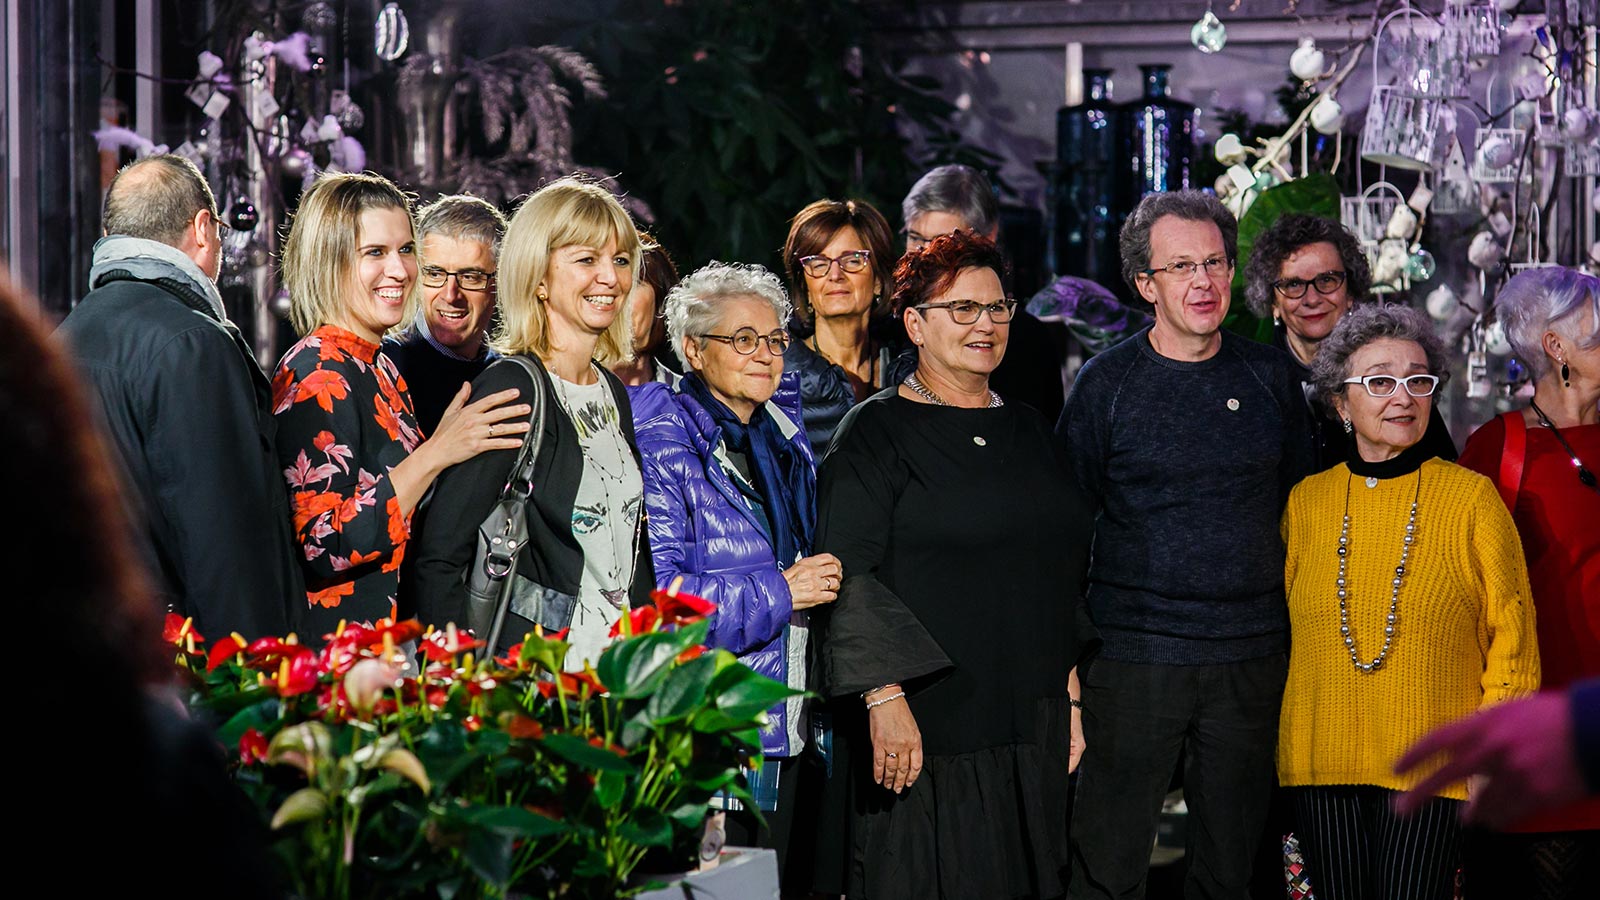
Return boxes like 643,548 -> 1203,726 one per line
1056,328 -> 1310,665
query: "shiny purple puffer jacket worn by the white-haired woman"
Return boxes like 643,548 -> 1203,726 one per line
629,372 -> 814,756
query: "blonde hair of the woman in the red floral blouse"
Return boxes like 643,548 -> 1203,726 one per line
283,171 -> 419,338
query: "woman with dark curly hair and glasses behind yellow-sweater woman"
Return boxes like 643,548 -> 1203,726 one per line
1245,213 -> 1456,472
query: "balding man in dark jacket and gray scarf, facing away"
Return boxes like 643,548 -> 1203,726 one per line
58,154 -> 300,641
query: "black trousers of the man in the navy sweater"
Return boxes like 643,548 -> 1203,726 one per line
1067,653 -> 1288,900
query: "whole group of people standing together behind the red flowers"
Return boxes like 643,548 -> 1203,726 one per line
18,148 -> 1600,900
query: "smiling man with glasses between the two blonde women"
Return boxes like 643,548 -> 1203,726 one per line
384,194 -> 506,434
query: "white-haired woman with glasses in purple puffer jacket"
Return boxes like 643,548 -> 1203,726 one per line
630,263 -> 840,871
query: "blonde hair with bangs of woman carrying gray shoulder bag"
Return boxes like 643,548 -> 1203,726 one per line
490,176 -> 642,368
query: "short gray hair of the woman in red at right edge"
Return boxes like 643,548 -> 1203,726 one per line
1494,266 -> 1600,381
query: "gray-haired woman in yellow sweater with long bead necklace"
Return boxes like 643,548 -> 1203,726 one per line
1278,306 -> 1539,900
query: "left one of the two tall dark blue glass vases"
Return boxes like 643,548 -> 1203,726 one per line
1054,69 -> 1122,283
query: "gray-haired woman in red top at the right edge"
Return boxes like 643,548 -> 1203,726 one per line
1461,267 -> 1600,898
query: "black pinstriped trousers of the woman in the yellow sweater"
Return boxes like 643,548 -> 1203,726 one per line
1291,785 -> 1461,900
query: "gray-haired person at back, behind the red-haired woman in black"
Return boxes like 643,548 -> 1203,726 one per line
901,165 -> 1066,421
